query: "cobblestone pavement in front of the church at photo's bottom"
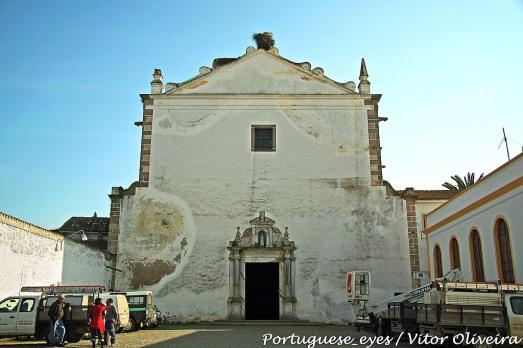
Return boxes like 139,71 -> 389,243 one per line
0,324 -> 413,348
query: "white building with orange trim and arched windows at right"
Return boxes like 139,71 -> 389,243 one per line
425,154 -> 523,283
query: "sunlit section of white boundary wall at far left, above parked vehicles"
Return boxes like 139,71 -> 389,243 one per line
0,222 -> 63,298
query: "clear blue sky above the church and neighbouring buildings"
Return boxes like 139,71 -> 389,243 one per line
0,0 -> 523,228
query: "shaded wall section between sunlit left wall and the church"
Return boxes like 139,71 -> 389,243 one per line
61,239 -> 111,286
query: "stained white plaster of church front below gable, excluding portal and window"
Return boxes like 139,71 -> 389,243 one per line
117,93 -> 410,322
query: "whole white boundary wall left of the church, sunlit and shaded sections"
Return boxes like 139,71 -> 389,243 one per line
0,213 -> 110,298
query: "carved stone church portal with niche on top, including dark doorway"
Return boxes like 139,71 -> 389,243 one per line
227,211 -> 297,320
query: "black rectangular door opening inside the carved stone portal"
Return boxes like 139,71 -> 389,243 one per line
245,262 -> 280,320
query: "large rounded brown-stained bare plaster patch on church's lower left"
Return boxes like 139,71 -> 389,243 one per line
117,188 -> 194,289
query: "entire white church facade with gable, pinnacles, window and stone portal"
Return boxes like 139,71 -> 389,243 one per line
108,43 -> 419,322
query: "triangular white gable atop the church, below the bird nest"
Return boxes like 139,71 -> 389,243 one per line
167,50 -> 355,95
